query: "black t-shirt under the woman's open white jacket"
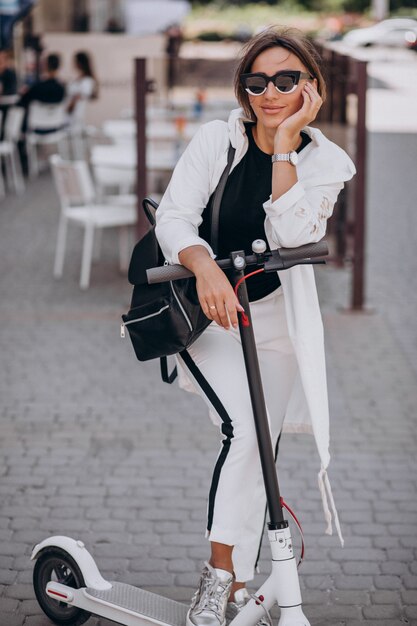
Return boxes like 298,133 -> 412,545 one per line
199,122 -> 311,302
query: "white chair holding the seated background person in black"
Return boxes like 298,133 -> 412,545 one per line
26,102 -> 68,178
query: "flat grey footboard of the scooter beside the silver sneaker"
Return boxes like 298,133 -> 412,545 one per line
85,582 -> 188,626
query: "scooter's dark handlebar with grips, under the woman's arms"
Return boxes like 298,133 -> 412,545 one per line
146,241 -> 329,285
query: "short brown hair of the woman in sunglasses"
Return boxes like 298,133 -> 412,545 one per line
234,27 -> 326,121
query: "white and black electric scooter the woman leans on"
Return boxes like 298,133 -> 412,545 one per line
31,240 -> 328,626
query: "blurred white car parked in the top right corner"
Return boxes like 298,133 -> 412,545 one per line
343,17 -> 417,47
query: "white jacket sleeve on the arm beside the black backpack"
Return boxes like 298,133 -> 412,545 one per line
155,122 -> 227,263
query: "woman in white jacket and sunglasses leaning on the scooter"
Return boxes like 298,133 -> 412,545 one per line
156,29 -> 355,626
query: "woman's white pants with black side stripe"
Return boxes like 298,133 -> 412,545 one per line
179,287 -> 297,582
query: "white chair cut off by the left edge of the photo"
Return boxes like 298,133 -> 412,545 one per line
0,107 -> 25,193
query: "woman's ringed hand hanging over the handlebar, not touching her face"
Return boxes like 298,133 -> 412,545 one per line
196,259 -> 243,329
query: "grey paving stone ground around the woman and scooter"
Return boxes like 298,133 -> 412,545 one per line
0,128 -> 417,626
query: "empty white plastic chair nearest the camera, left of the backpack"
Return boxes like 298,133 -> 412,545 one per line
50,155 -> 137,289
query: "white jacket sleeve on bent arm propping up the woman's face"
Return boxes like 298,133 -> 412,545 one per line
263,181 -> 343,248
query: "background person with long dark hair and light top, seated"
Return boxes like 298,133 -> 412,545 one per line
67,51 -> 99,125
